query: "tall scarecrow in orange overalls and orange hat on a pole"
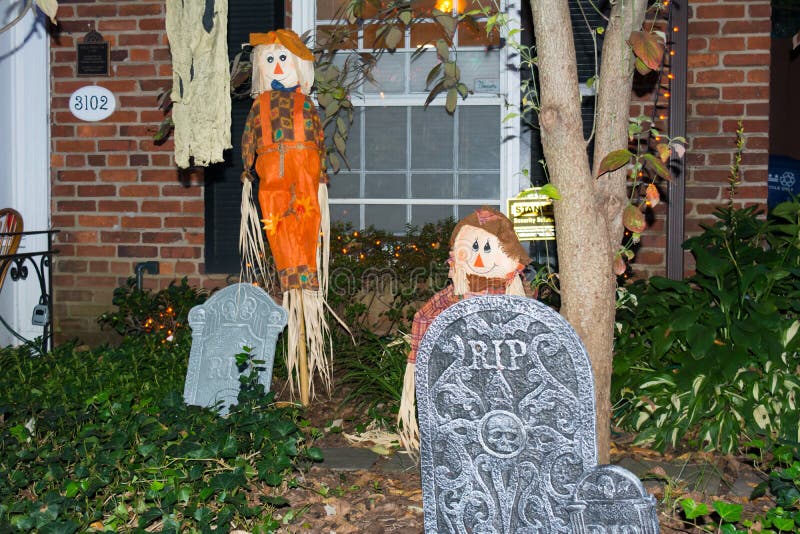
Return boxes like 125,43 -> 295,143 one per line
240,30 -> 332,405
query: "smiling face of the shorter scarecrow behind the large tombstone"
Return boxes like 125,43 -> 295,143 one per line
453,225 -> 518,278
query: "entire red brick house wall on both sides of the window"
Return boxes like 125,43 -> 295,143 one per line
51,0 -> 770,341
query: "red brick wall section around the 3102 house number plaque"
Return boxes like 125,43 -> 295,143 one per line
50,0 -> 228,341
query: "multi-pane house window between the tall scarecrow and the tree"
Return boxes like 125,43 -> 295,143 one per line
304,0 -> 526,233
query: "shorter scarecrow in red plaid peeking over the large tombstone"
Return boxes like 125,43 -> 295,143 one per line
397,207 -> 531,451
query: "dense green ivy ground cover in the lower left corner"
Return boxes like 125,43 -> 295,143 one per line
0,324 -> 320,533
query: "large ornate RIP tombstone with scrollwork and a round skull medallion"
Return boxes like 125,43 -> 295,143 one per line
416,296 -> 597,534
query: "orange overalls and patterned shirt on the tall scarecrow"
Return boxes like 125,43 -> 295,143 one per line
242,88 -> 328,291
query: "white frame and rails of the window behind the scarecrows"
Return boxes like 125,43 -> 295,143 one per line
291,0 -> 529,228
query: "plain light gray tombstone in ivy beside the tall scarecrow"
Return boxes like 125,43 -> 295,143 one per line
183,284 -> 288,415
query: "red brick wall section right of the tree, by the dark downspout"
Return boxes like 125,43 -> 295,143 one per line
634,0 -> 771,276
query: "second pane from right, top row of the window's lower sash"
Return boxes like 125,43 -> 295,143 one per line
411,106 -> 453,169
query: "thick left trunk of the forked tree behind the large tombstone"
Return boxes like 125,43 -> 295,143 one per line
530,0 -> 643,463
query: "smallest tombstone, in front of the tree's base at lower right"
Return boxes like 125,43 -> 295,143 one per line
569,465 -> 659,534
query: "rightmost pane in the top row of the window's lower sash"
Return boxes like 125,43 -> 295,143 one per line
458,106 -> 501,170
